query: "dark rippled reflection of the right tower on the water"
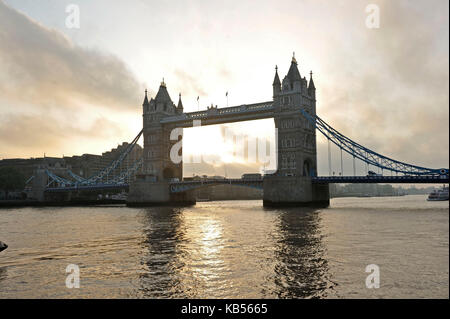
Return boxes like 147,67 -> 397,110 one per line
273,208 -> 334,298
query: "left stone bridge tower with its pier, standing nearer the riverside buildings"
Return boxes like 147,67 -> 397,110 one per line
128,80 -> 191,205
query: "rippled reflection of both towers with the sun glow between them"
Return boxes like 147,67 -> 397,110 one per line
140,206 -> 333,298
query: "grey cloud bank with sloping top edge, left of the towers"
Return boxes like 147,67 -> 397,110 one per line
0,1 -> 142,111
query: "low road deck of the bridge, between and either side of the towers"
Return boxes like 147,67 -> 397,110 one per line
45,175 -> 449,193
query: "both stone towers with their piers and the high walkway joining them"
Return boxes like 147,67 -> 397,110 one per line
128,53 -> 329,206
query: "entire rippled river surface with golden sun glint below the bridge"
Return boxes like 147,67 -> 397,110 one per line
0,195 -> 449,298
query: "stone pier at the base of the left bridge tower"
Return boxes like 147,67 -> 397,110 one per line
127,175 -> 195,206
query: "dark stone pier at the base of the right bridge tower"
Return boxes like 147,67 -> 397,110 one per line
263,175 -> 330,207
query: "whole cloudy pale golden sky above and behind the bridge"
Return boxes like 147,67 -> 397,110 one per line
0,0 -> 449,176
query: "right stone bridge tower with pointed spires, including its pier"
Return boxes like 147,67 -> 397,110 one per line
264,55 -> 329,206
